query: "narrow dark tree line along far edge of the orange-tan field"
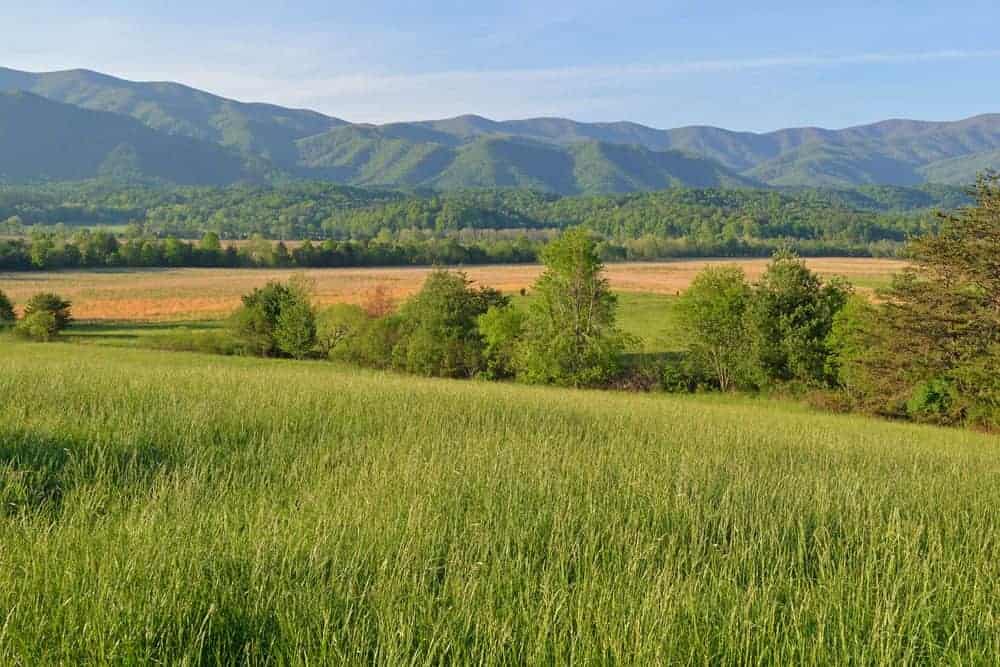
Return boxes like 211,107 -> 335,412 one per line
0,229 -> 896,271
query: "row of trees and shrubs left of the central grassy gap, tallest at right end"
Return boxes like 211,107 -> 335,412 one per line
233,230 -> 630,387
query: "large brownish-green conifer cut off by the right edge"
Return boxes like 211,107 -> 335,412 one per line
865,175 -> 1000,426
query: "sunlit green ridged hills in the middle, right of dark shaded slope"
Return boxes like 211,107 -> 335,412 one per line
298,125 -> 759,194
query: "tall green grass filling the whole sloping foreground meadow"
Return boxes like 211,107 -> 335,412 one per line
0,340 -> 1000,665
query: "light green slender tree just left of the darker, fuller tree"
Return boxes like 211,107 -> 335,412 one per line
677,266 -> 751,391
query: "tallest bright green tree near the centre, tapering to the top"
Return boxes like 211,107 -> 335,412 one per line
516,229 -> 628,387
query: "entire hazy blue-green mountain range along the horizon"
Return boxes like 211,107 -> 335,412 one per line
0,68 -> 1000,194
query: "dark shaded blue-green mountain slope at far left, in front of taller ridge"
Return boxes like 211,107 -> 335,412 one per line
0,92 -> 268,185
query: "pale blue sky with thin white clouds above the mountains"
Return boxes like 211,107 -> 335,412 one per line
0,0 -> 1000,131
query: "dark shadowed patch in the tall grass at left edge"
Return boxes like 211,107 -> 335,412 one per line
0,427 -> 173,518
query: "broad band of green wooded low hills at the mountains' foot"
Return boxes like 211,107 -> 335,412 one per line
0,183 -> 965,254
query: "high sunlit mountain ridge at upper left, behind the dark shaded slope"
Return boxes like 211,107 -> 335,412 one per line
0,68 -> 345,165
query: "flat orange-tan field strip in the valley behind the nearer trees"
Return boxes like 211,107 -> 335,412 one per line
0,258 -> 906,321
